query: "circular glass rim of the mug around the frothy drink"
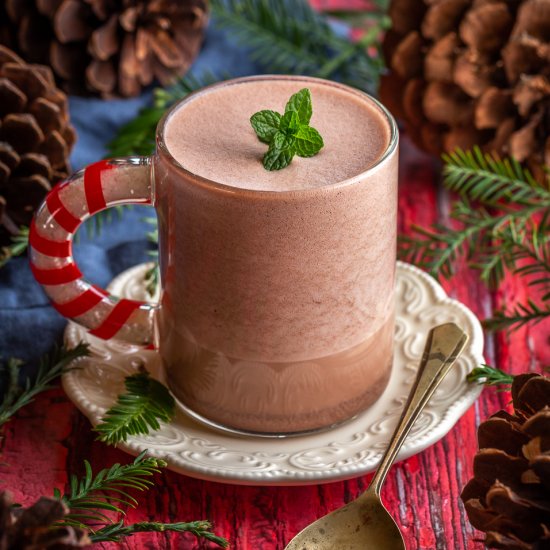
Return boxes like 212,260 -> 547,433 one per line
155,74 -> 399,198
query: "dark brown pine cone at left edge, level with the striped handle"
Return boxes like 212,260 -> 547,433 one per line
0,46 -> 76,246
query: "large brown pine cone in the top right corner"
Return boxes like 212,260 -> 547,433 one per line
380,0 -> 550,177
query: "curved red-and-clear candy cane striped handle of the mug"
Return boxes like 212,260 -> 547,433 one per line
29,157 -> 155,347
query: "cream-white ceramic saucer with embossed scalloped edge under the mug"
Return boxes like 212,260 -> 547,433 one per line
63,263 -> 483,485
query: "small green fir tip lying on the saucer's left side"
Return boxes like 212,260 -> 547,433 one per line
94,369 -> 175,445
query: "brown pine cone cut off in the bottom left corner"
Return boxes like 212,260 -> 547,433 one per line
0,493 -> 91,550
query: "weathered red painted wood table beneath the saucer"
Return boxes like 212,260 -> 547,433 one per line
0,2 -> 550,550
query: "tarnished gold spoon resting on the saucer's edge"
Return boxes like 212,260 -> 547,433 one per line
285,323 -> 468,550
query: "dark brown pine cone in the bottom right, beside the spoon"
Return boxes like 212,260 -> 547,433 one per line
461,374 -> 550,550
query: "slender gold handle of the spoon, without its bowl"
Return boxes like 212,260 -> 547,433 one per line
367,323 -> 468,496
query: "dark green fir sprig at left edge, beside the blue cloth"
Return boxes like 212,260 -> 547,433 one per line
0,343 -> 88,426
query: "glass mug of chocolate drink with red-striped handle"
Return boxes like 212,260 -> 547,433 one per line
30,76 -> 398,436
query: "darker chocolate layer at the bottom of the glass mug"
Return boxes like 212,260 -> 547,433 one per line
161,315 -> 394,437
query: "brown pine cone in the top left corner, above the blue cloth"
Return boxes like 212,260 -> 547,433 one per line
0,0 -> 207,98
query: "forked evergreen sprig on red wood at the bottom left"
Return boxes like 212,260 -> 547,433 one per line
54,451 -> 228,548
